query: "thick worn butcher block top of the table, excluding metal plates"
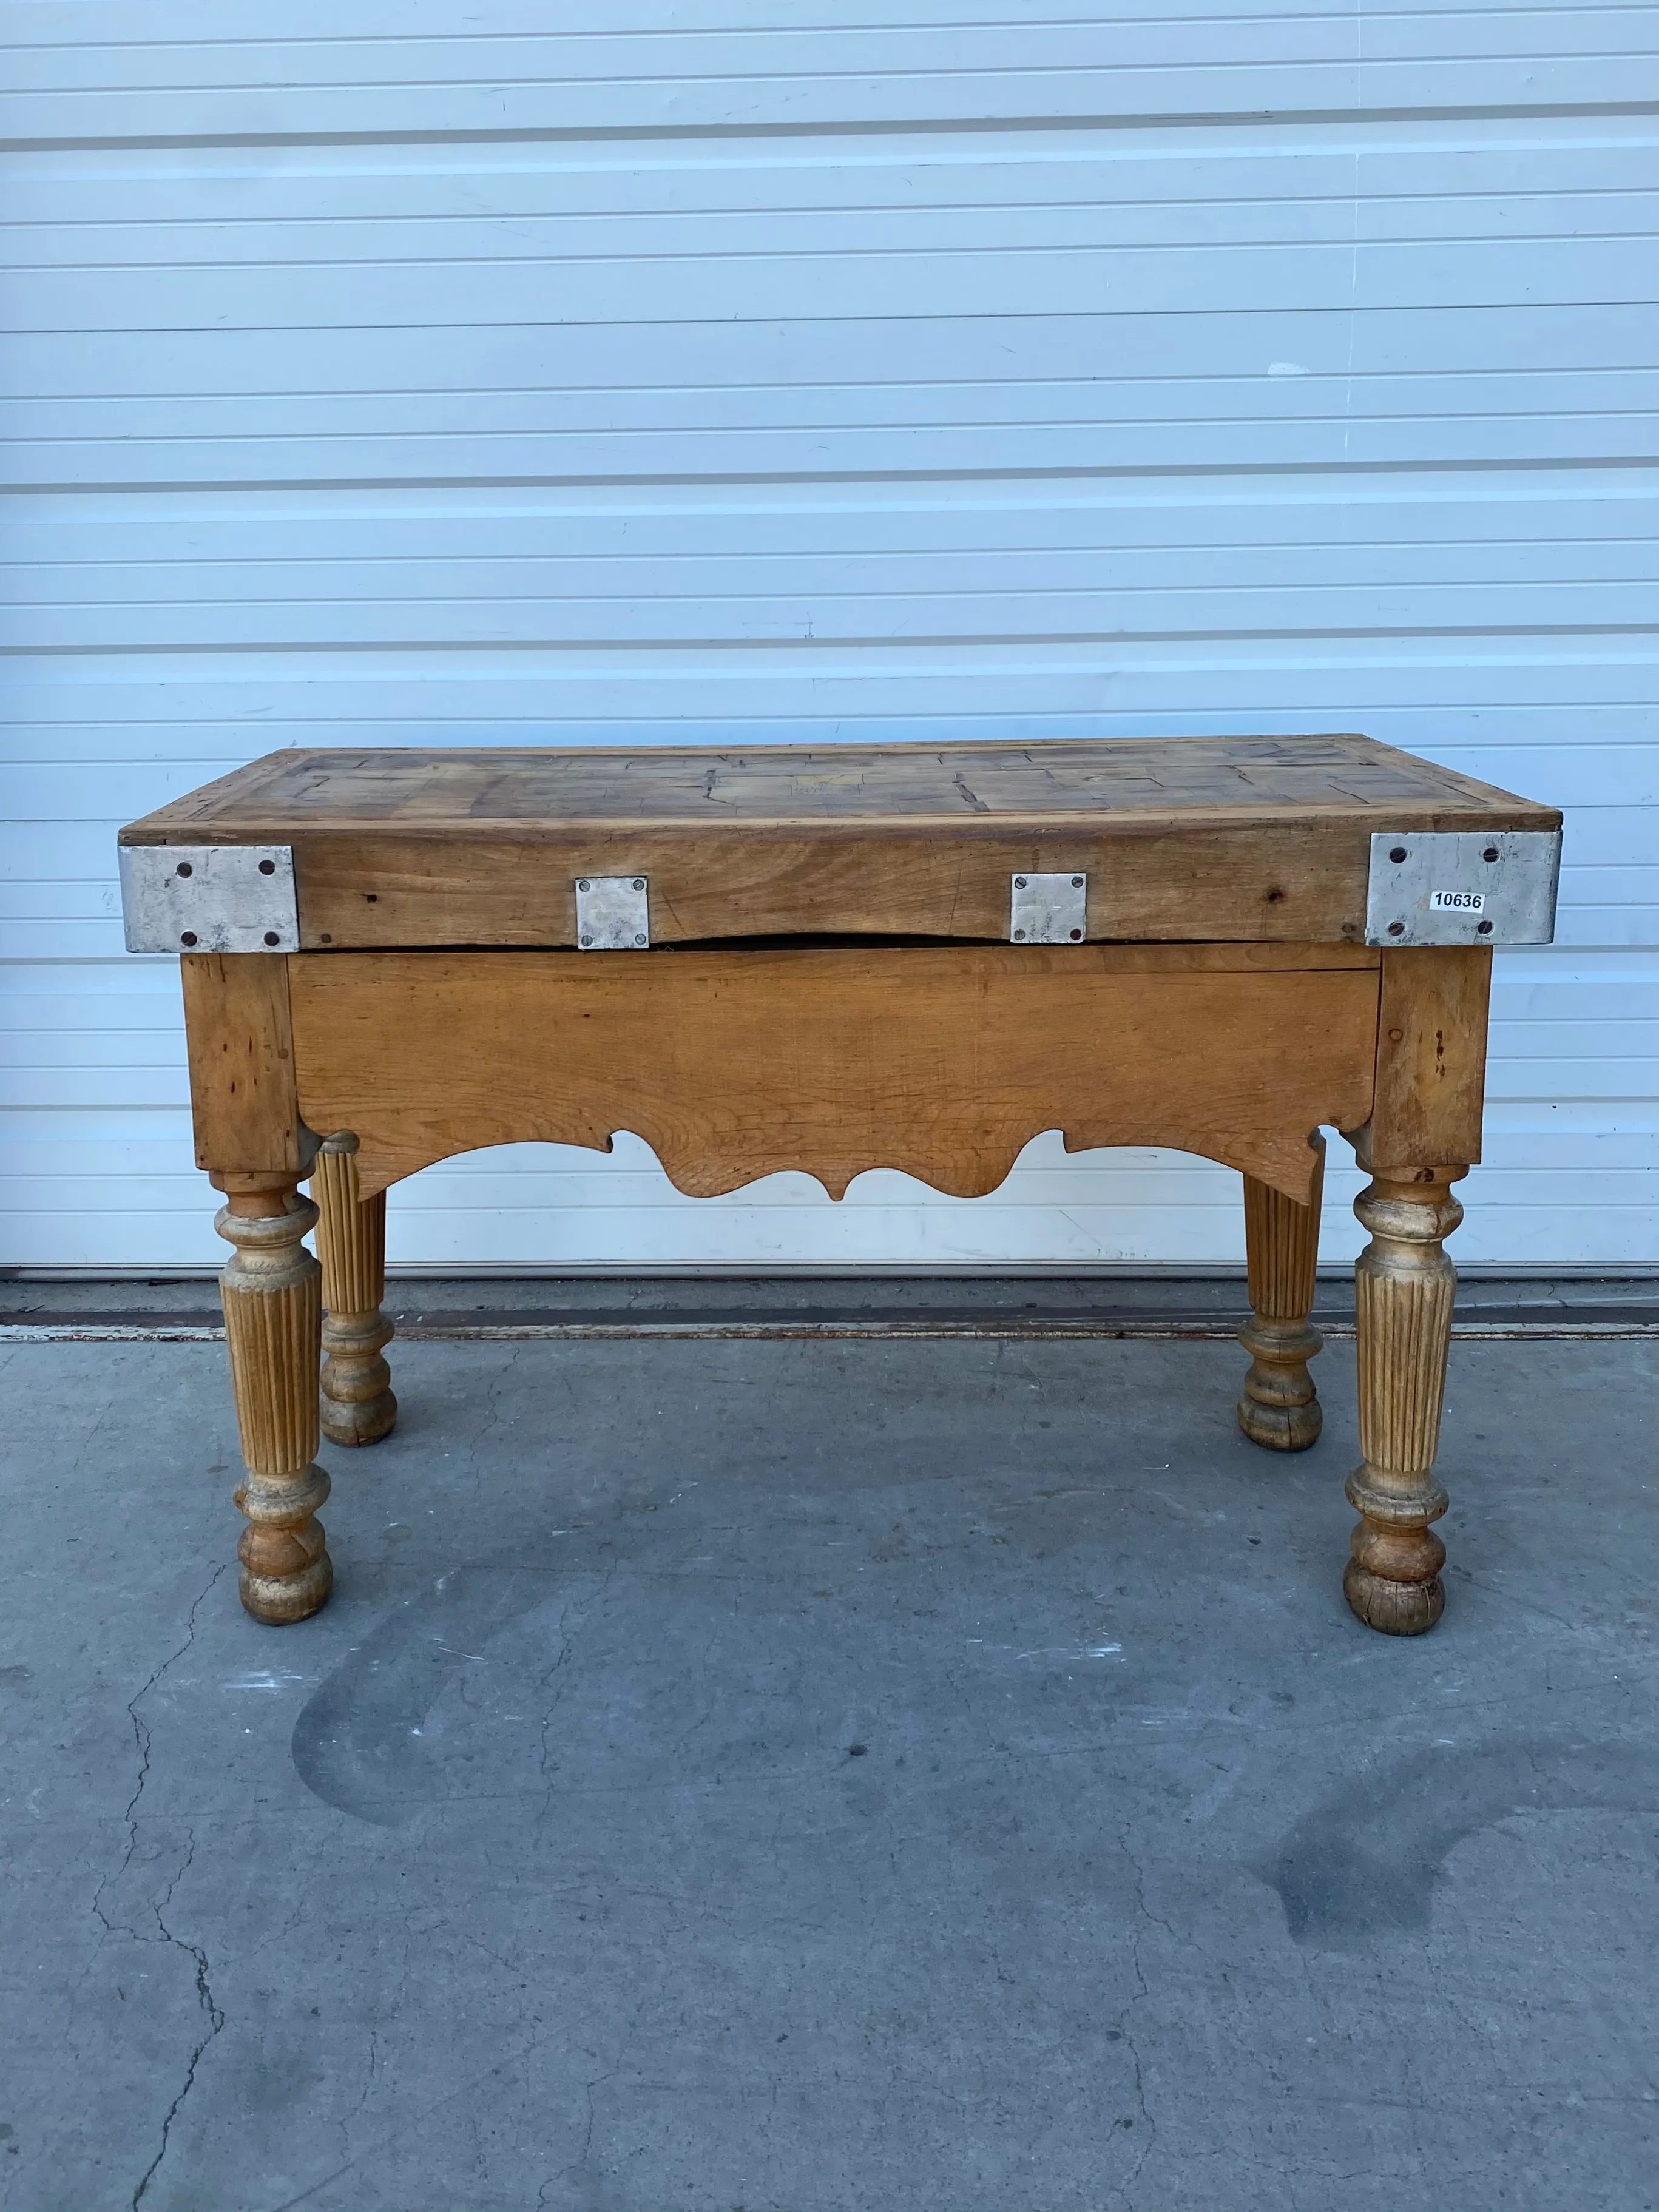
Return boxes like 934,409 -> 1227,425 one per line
121,737 -> 1562,949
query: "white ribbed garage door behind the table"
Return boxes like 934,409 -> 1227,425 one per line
0,0 -> 1659,1267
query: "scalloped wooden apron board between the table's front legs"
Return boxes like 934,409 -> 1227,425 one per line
292,946 -> 1378,1201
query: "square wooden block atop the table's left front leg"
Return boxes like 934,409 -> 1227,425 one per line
179,953 -> 308,1177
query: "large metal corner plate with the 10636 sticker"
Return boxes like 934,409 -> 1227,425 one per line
1365,829 -> 1562,945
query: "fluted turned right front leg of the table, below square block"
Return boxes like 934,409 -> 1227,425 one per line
1343,1161 -> 1469,1637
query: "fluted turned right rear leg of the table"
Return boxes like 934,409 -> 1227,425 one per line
1238,1135 -> 1325,1451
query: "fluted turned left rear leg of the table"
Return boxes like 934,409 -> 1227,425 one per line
312,1130 -> 398,1445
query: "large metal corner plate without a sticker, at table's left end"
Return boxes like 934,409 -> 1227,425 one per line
121,845 -> 299,953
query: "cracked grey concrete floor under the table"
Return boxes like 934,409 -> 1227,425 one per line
0,1340 -> 1659,2212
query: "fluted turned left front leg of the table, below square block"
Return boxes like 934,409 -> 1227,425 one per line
215,1184 -> 334,1622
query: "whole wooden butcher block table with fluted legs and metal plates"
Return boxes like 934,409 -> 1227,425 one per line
121,737 -> 1562,1634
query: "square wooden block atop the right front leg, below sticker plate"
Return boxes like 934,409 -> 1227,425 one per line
1367,945 -> 1491,1172
